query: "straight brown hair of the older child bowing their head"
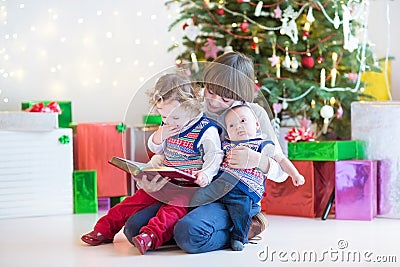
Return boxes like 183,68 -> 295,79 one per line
203,52 -> 255,102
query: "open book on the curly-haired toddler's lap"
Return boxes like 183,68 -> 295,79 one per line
108,157 -> 198,187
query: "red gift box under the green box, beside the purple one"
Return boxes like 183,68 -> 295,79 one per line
261,160 -> 335,217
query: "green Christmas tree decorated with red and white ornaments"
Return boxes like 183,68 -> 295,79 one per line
166,0 -> 379,139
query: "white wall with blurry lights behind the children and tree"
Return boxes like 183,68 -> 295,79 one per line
0,0 -> 400,124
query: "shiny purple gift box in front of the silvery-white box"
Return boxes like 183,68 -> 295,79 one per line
335,160 -> 378,220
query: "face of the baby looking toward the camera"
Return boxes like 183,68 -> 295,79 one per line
225,107 -> 260,141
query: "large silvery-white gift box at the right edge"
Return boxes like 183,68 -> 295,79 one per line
351,101 -> 400,218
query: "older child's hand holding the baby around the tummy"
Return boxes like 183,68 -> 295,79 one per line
226,146 -> 261,169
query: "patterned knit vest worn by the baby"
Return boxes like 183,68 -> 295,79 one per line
220,138 -> 274,202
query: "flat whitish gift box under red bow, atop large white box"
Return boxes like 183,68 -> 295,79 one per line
0,111 -> 58,131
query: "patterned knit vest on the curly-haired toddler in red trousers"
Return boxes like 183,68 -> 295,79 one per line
163,116 -> 218,173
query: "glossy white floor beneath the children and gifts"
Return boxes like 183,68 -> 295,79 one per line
0,214 -> 400,267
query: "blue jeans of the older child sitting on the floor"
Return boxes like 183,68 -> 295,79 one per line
124,202 -> 261,253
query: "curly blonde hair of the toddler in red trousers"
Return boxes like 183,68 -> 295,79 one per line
147,73 -> 203,113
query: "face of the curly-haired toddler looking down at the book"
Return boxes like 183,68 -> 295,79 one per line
156,99 -> 197,129
